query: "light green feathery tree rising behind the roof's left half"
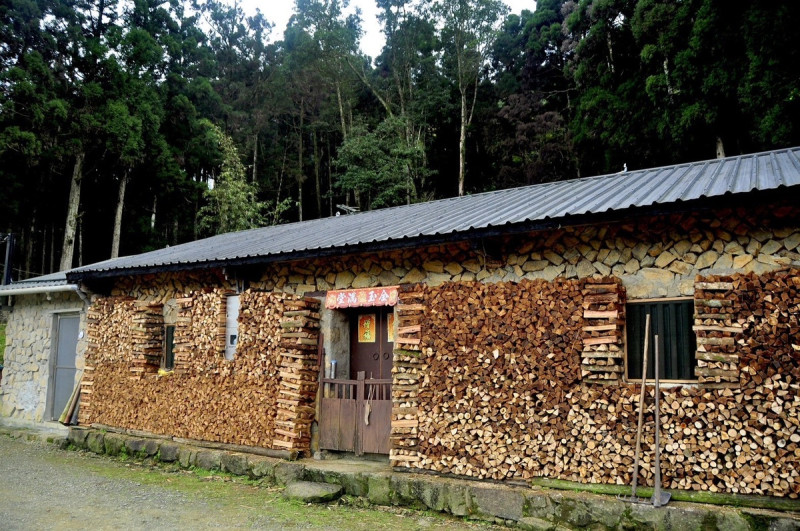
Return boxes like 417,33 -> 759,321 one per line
198,125 -> 267,234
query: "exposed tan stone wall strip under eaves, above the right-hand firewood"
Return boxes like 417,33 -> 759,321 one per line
252,205 -> 800,300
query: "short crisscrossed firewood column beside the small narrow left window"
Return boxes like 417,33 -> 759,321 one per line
130,301 -> 164,377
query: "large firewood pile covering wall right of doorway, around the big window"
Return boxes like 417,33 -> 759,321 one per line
404,270 -> 800,498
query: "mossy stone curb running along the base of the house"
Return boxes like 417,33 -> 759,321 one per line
57,427 -> 800,531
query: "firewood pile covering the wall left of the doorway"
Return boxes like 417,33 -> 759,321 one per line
80,289 -> 316,450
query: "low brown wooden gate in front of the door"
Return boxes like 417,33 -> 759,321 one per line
319,372 -> 392,455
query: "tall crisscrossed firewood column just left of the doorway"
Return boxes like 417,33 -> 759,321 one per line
272,297 -> 320,452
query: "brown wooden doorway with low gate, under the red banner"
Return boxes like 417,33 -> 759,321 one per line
319,306 -> 394,455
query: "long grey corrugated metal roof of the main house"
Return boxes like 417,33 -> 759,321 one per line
69,147 -> 800,279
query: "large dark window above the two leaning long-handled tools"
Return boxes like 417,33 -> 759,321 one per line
626,299 -> 697,380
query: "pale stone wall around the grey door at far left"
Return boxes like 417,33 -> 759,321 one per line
0,292 -> 86,423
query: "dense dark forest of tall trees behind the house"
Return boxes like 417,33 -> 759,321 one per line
0,0 -> 800,279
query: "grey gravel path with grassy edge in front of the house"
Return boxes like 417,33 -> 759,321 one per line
0,436 -> 494,530
